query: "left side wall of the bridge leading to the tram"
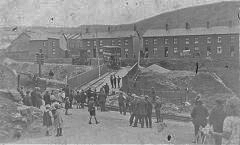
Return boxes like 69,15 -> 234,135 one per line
67,65 -> 108,88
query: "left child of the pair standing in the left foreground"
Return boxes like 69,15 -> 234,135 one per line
43,104 -> 53,136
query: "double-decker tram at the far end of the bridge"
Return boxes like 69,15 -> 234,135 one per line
102,46 -> 122,69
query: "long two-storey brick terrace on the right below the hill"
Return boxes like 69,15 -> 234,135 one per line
143,23 -> 240,62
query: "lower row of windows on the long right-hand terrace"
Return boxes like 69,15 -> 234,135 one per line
149,46 -> 234,57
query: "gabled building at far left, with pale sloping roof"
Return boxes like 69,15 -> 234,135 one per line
6,31 -> 67,61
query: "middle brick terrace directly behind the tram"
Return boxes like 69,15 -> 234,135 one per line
65,30 -> 140,58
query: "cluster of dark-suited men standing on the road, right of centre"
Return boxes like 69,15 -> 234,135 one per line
118,92 -> 163,128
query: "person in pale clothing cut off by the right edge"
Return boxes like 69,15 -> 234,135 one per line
210,96 -> 240,145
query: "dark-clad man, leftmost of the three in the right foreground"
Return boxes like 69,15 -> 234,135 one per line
191,100 -> 209,143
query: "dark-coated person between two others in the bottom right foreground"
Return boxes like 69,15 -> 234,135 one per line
209,100 -> 226,145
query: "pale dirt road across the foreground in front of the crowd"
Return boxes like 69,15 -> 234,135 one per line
15,109 -> 193,144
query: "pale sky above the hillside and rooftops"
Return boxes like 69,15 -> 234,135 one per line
0,0 -> 236,27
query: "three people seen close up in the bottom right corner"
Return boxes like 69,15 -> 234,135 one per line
191,96 -> 240,145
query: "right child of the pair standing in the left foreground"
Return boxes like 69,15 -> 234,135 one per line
54,104 -> 63,136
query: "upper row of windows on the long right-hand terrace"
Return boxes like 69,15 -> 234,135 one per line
145,36 -> 235,45
